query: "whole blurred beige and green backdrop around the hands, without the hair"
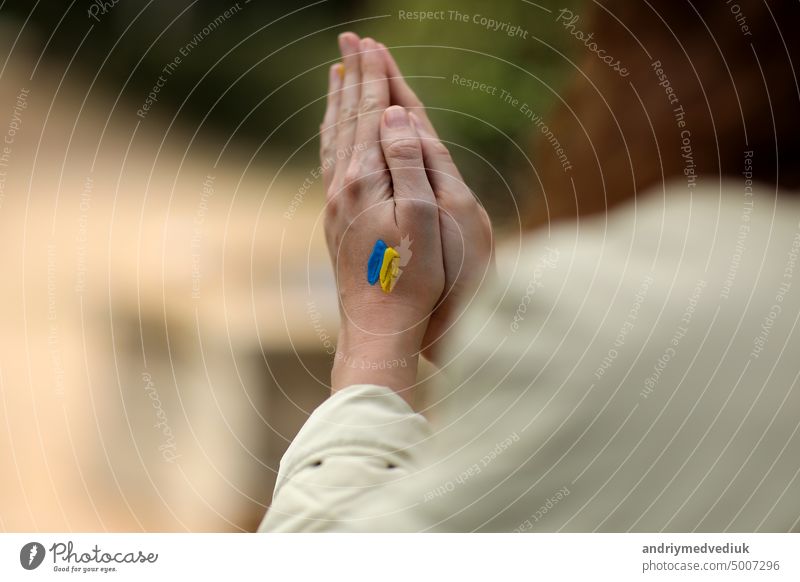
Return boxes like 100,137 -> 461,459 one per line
0,0 -> 577,531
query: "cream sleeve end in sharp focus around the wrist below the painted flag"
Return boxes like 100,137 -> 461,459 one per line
259,384 -> 430,532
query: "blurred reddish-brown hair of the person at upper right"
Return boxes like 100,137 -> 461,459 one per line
526,0 -> 800,226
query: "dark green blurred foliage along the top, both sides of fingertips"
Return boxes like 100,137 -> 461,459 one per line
0,0 -> 580,224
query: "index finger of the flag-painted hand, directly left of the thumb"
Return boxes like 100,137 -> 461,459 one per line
355,38 -> 389,155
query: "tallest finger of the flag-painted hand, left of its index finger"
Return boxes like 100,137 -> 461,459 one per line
336,32 -> 361,179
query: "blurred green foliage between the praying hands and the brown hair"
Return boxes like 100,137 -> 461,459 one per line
364,0 -> 580,223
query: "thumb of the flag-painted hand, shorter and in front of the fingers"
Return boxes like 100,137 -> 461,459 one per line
381,105 -> 436,212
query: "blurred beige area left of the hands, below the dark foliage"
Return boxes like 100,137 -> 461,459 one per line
0,50 -> 337,531
